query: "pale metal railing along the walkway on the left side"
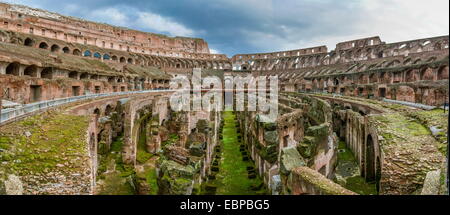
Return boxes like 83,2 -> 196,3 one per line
0,90 -> 173,124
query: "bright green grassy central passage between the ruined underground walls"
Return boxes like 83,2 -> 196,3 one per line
213,111 -> 266,195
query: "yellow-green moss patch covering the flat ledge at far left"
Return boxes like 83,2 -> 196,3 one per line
2,113 -> 89,175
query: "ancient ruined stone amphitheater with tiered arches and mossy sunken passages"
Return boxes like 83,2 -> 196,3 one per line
0,3 -> 449,195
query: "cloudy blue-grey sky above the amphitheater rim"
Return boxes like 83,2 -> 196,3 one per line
0,0 -> 449,57
